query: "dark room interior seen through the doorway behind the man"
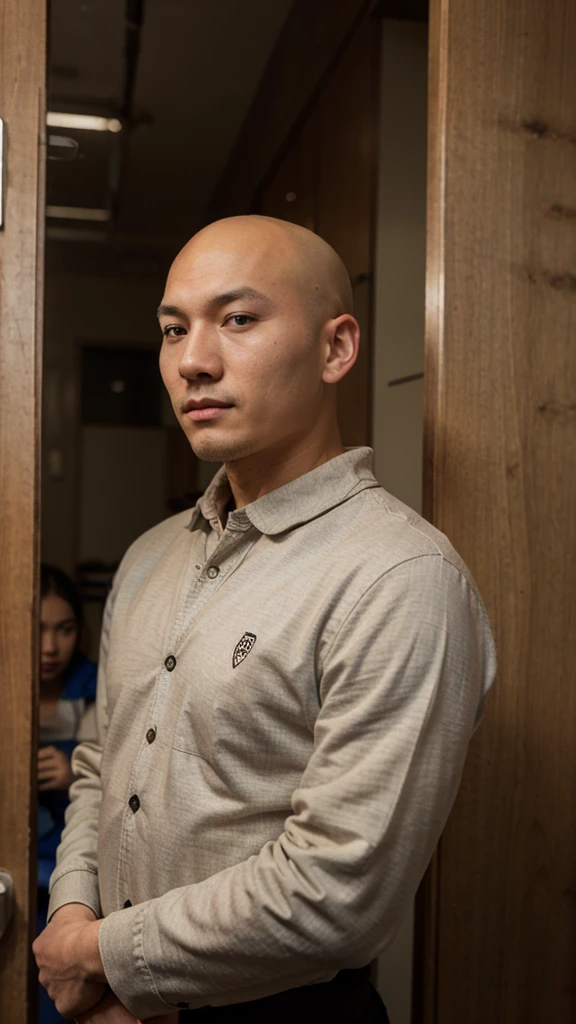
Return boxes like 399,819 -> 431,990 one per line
3,0 -> 425,1024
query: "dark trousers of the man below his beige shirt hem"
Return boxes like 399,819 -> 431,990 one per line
179,967 -> 389,1024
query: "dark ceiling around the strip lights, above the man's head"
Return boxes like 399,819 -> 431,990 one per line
47,0 -> 292,244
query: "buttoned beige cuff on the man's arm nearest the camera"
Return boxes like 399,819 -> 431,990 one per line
98,902 -> 178,1020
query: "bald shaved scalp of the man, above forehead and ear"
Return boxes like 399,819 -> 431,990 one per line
170,214 -> 353,325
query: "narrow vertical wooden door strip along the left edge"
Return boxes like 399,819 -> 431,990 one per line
0,0 -> 46,1024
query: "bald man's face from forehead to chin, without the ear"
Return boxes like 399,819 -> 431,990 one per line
159,236 -> 325,462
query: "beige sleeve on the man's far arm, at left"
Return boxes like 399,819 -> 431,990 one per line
48,591 -> 114,920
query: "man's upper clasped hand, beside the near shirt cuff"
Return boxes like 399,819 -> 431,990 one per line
32,903 -> 107,1017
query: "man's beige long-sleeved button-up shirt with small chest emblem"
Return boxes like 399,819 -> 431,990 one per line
50,449 -> 495,1019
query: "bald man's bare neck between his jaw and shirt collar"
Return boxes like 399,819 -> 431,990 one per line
225,435 -> 344,509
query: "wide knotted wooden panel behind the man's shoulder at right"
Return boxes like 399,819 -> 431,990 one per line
419,0 -> 576,1024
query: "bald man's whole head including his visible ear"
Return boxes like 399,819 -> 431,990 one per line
158,216 -> 359,462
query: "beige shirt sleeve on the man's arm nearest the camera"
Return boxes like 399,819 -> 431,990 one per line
97,555 -> 495,1019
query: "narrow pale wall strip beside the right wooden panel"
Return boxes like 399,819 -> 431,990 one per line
372,19 -> 427,1024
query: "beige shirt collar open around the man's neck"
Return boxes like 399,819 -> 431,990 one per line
189,447 -> 380,537
